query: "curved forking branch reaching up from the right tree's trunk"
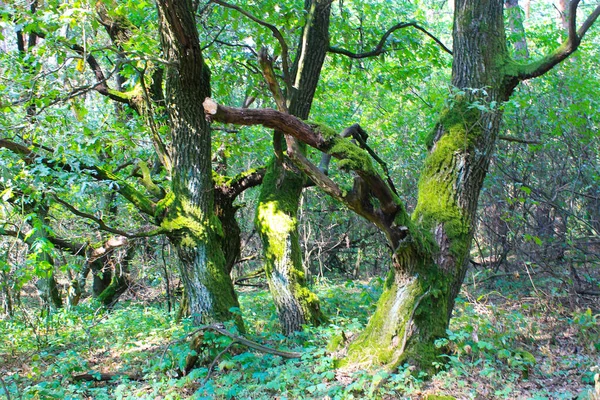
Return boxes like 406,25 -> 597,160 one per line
515,0 -> 600,81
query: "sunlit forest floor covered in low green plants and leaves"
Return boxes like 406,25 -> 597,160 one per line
0,274 -> 600,400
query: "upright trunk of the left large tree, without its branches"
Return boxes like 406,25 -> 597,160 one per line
157,0 -> 243,329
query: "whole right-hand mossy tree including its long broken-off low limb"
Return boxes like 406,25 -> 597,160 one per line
204,0 -> 600,368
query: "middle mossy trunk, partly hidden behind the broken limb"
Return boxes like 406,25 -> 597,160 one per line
256,0 -> 331,334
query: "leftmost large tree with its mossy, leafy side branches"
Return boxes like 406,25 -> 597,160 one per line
0,1 -> 256,329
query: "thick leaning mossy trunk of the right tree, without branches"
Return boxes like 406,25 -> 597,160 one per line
343,0 -> 515,368
